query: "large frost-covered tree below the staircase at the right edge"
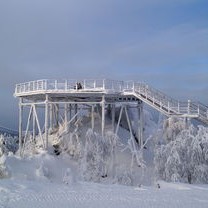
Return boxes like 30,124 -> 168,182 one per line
155,126 -> 208,183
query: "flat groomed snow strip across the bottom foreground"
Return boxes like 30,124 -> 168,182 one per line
0,179 -> 208,208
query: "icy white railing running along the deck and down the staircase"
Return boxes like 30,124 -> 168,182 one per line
15,79 -> 208,122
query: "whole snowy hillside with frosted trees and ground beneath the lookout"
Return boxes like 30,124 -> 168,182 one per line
0,106 -> 208,208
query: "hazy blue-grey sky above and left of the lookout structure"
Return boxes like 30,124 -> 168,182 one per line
0,0 -> 208,128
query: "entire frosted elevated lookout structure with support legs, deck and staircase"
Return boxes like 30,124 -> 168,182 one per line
14,79 -> 208,155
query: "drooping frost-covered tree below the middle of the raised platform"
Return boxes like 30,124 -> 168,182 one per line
81,129 -> 117,182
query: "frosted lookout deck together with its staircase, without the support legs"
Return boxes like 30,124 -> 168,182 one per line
14,79 -> 208,124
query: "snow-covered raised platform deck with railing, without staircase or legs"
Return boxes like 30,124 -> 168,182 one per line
14,80 -> 138,103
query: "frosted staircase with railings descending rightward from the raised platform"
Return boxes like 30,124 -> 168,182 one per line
124,83 -> 208,125
